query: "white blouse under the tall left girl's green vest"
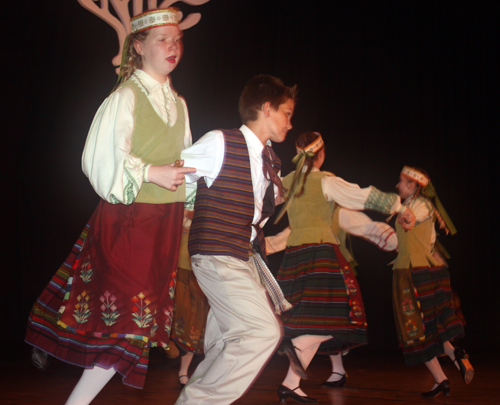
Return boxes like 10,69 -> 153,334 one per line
82,69 -> 191,204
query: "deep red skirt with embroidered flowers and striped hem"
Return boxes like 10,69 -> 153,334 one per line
26,201 -> 183,388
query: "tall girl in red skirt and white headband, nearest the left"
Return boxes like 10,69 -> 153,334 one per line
26,8 -> 195,404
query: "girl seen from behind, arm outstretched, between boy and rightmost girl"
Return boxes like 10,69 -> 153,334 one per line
277,132 -> 413,403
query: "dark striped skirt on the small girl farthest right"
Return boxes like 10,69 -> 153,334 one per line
393,266 -> 464,365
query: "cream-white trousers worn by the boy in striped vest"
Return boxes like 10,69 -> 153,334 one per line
176,255 -> 282,405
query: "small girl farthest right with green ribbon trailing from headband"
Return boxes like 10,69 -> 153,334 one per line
393,166 -> 474,397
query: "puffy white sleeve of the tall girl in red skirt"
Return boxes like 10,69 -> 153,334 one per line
82,88 -> 147,204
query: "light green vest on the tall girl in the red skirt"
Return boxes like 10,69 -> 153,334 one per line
122,80 -> 186,204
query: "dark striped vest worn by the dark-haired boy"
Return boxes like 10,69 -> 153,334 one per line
189,129 -> 280,261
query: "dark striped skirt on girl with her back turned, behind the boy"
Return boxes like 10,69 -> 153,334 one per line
277,243 -> 367,354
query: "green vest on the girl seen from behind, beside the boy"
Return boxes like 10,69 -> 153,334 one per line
283,172 -> 339,246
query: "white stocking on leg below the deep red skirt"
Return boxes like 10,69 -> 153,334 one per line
66,366 -> 116,405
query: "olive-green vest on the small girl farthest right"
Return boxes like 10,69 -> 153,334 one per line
393,199 -> 439,269
